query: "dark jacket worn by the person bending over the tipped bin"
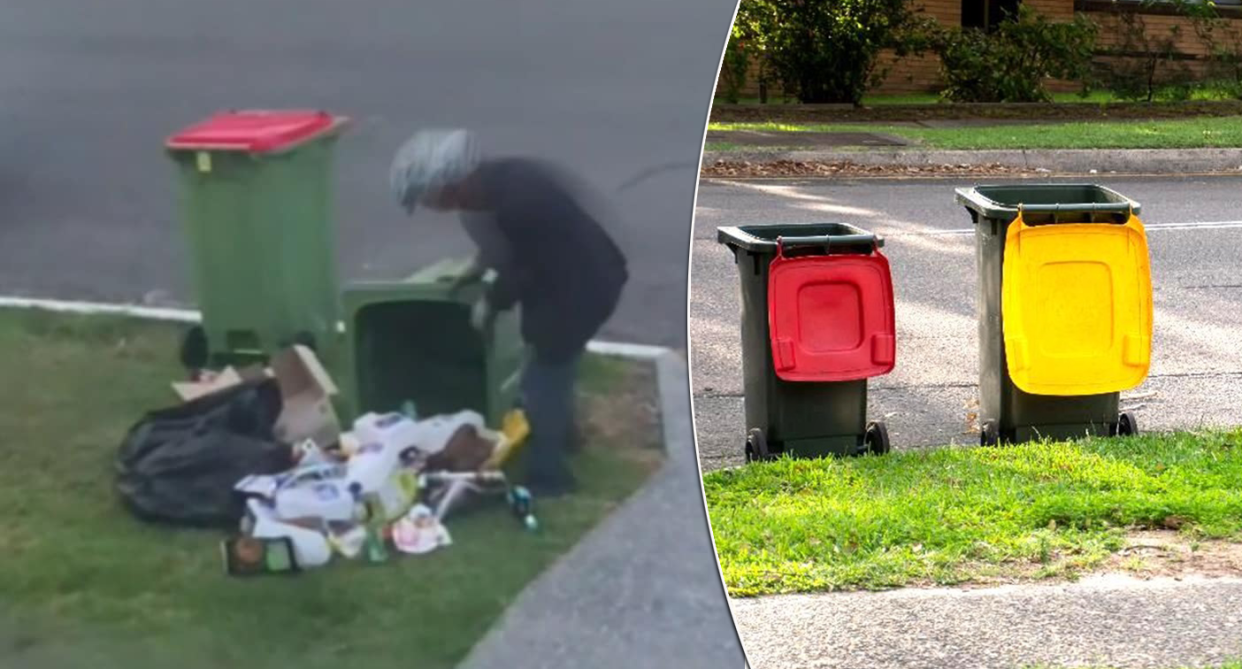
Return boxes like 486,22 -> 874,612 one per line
471,158 -> 628,362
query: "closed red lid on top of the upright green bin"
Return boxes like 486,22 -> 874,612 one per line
165,109 -> 340,153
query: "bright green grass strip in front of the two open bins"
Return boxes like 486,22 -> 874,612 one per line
704,429 -> 1242,596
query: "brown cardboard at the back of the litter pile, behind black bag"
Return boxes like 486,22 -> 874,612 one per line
173,346 -> 340,448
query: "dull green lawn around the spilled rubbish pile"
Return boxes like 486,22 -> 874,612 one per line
0,310 -> 660,669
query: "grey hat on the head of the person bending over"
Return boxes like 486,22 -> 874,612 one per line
389,129 -> 479,212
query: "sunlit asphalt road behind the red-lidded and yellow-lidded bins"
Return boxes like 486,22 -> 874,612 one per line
689,177 -> 1242,469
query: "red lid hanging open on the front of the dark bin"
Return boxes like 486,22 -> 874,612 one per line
768,248 -> 897,381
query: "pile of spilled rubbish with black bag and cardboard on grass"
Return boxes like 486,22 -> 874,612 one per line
117,346 -> 538,575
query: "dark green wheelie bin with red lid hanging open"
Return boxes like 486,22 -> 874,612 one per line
717,223 -> 895,462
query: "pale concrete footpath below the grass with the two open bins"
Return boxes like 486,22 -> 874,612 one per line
733,576 -> 1242,669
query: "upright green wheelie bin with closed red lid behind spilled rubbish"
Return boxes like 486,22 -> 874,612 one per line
165,110 -> 348,369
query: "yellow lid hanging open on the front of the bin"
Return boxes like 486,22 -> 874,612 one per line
1001,212 -> 1151,396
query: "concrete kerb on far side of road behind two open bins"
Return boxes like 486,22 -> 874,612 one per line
703,149 -> 1242,174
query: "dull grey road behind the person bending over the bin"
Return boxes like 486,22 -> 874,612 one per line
0,0 -> 735,348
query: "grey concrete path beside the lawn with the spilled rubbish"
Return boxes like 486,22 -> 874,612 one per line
460,352 -> 745,669
